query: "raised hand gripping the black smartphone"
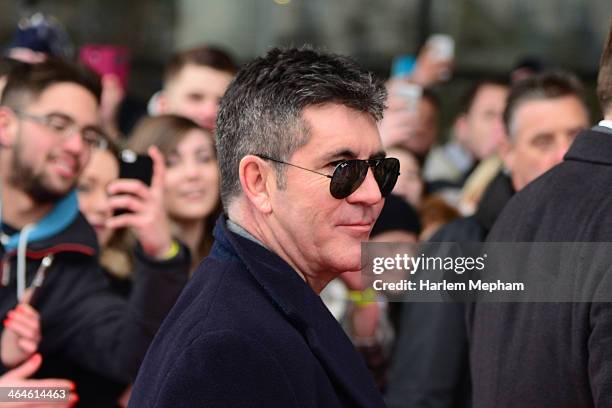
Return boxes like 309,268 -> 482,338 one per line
107,147 -> 173,259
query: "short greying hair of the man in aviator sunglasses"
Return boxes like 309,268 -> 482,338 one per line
216,47 -> 387,212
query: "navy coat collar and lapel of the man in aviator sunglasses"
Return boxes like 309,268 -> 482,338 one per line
212,215 -> 384,407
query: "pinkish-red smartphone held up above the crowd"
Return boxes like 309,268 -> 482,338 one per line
79,44 -> 130,90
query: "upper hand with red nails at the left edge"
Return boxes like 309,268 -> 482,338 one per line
0,296 -> 41,367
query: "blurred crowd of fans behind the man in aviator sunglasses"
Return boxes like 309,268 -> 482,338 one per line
0,10 -> 608,408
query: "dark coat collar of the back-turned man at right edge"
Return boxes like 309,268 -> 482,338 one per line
564,126 -> 612,165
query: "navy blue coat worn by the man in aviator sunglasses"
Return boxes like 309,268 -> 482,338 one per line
130,218 -> 384,408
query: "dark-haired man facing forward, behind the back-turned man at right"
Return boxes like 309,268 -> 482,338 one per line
385,68 -> 588,408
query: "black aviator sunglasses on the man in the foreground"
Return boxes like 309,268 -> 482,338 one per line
256,154 -> 399,199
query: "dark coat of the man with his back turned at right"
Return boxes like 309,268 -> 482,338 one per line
469,127 -> 612,408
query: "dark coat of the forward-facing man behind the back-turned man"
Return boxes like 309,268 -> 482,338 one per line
385,172 -> 514,408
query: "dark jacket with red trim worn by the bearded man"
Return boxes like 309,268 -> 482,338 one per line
0,214 -> 190,407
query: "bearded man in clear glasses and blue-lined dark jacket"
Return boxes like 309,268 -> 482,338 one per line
0,60 -> 190,406
